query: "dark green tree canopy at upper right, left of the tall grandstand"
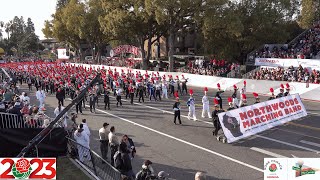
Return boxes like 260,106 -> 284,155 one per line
202,0 -> 298,61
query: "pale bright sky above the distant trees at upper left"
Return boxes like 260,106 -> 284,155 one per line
0,0 -> 57,39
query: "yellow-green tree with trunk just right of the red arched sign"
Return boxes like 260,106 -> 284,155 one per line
100,0 -> 165,69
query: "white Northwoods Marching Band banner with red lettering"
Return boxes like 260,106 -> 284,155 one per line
218,94 -> 307,143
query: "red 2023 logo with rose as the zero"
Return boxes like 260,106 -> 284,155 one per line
0,158 -> 56,179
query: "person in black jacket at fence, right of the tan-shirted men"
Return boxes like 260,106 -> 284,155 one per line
119,142 -> 135,179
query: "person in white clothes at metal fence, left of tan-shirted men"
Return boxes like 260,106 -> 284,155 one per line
74,124 -> 91,162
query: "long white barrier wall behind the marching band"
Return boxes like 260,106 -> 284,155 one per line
70,63 -> 320,101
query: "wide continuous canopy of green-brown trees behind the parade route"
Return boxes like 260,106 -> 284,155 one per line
39,0 -> 304,65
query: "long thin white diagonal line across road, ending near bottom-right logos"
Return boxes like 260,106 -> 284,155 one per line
86,105 -> 264,172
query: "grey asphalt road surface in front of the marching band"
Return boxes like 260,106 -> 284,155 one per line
22,83 -> 320,180
